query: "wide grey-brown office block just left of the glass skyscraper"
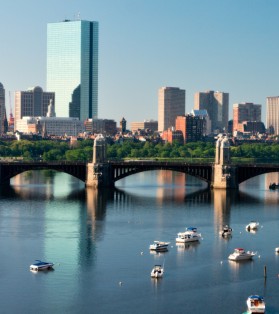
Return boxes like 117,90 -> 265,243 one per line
14,86 -> 55,131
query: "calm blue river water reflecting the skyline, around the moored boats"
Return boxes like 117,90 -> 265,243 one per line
0,171 -> 279,314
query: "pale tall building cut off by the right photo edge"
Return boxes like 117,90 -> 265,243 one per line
266,96 -> 279,135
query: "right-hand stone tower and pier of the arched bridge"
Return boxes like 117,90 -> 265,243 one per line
211,136 -> 238,189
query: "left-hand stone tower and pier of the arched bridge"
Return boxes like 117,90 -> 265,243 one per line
85,134 -> 114,188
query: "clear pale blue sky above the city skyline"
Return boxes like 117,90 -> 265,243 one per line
0,0 -> 279,124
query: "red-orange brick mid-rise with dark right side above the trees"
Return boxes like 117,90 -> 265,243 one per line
175,114 -> 206,143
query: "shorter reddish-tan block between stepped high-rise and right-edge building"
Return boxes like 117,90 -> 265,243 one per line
233,103 -> 262,132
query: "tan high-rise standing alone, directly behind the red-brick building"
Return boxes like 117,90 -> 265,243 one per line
158,87 -> 185,132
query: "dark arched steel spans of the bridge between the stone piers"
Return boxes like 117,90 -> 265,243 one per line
0,160 -> 279,185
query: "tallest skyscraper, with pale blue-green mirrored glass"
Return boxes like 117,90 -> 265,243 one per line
47,20 -> 99,121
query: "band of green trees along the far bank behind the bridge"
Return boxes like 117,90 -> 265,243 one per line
0,140 -> 279,161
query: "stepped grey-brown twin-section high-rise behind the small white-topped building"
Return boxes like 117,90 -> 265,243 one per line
194,91 -> 229,132
